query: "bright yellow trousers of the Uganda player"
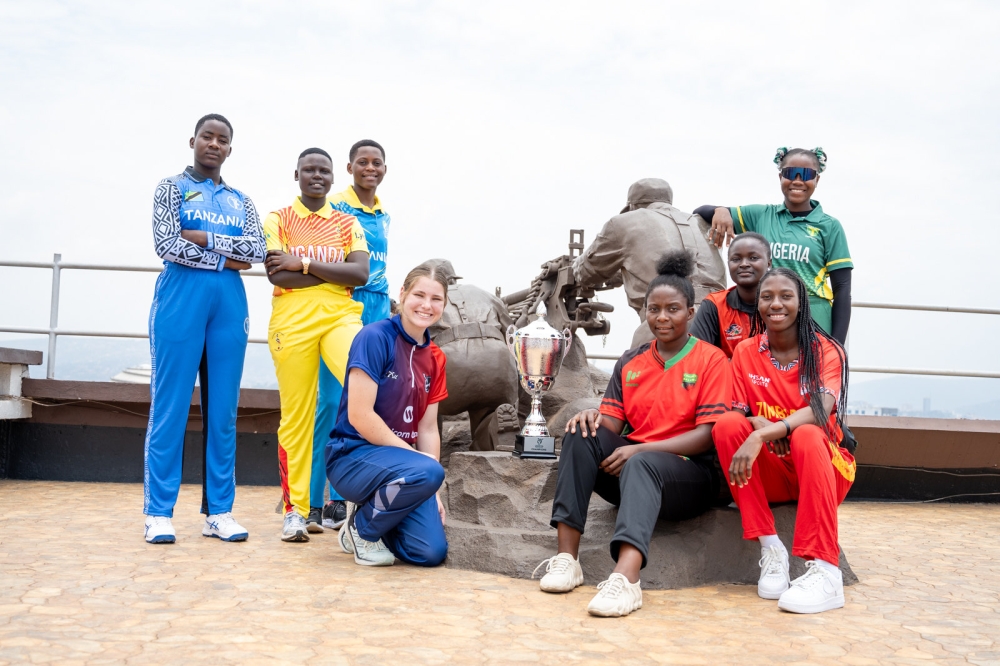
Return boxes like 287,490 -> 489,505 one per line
267,289 -> 364,518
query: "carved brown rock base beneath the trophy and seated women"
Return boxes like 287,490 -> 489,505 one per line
443,452 -> 858,589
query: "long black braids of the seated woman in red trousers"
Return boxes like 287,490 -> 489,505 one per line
750,268 -> 849,444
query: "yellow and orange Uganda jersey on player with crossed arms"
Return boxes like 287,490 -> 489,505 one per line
264,197 -> 368,298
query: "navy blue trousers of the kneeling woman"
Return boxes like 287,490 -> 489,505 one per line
327,444 -> 448,567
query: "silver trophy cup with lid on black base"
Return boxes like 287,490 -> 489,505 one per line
507,305 -> 573,458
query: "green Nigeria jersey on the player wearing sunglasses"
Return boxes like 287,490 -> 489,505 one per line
729,201 -> 854,332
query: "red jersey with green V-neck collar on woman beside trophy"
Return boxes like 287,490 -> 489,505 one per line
601,337 -> 732,443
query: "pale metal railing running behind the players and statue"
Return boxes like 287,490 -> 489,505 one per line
0,254 -> 1000,379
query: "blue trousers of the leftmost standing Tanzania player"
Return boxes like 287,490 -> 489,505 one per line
143,263 -> 250,517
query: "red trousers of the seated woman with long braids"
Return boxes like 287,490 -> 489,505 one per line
712,412 -> 854,564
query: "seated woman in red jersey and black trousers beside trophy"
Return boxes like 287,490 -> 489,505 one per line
539,251 -> 732,616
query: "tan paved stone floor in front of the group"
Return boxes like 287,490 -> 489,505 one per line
0,481 -> 1000,665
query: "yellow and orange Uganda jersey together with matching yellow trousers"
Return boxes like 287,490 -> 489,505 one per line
264,197 -> 368,517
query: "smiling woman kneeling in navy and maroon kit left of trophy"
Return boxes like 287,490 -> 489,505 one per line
326,264 -> 448,567
